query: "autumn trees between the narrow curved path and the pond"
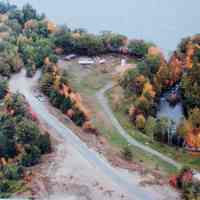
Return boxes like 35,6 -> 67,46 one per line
119,44 -> 184,146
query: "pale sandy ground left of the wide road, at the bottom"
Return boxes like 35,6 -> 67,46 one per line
31,138 -> 128,200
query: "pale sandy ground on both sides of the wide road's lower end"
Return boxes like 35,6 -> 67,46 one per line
27,134 -> 179,200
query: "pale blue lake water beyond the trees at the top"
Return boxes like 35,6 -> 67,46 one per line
7,0 -> 200,54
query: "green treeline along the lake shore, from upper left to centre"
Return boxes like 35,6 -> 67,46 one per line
0,3 -> 155,77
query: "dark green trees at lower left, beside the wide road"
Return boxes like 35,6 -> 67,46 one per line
0,93 -> 51,198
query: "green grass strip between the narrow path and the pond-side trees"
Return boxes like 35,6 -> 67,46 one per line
106,86 -> 200,170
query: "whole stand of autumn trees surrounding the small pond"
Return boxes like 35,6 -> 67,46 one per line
119,35 -> 200,151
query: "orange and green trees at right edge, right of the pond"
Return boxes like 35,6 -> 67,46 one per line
176,34 -> 200,151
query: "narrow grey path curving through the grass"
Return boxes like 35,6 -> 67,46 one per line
96,82 -> 182,169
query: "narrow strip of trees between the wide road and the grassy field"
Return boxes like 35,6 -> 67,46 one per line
40,59 -> 89,126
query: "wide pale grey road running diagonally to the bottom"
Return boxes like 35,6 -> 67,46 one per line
9,70 -> 164,200
